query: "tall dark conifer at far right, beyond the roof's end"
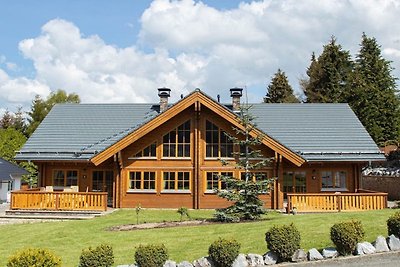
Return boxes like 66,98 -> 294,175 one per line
346,33 -> 400,147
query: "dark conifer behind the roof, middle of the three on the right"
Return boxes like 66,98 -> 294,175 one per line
301,36 -> 353,103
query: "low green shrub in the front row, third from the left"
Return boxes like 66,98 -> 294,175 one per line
135,244 -> 168,267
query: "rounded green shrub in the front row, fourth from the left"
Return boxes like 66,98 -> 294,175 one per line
208,238 -> 240,267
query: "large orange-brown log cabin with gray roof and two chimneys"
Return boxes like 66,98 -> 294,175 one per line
14,88 -> 386,211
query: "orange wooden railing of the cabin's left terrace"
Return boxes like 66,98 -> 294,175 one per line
10,191 -> 107,211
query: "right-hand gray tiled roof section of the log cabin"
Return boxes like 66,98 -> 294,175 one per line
250,104 -> 385,161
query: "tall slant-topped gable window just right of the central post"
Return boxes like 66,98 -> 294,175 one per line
204,120 -> 234,159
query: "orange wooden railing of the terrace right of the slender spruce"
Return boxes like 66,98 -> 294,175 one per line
287,192 -> 387,212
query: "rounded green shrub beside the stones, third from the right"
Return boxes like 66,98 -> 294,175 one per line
265,223 -> 300,261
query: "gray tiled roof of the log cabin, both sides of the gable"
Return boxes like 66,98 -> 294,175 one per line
16,95 -> 384,164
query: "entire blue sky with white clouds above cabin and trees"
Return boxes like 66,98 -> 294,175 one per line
0,0 -> 400,113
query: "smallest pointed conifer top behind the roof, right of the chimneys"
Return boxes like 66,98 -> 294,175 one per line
264,69 -> 299,103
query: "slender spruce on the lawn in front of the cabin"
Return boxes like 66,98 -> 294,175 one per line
215,106 -> 273,222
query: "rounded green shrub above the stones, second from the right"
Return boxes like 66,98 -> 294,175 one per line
331,220 -> 364,256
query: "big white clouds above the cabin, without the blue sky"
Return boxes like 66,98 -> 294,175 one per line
0,0 -> 400,112
